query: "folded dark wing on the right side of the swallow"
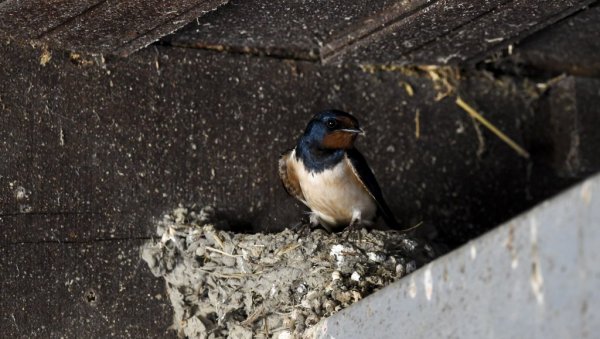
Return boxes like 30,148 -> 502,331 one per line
346,148 -> 401,230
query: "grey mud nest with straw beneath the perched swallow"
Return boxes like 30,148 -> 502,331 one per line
142,207 -> 435,338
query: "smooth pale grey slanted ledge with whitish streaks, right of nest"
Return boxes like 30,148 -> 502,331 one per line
315,175 -> 600,338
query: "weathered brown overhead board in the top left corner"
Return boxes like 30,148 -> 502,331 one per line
0,0 -> 227,55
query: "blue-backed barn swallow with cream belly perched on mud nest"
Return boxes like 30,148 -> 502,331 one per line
279,110 -> 399,231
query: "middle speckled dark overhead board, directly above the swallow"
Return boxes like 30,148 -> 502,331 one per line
163,0 -> 425,60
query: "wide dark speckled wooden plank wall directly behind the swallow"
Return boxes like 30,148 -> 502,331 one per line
0,40 -> 552,247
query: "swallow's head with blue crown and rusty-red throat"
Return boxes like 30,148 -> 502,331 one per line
303,110 -> 364,150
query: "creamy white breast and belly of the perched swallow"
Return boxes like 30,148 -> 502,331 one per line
290,151 -> 377,225
